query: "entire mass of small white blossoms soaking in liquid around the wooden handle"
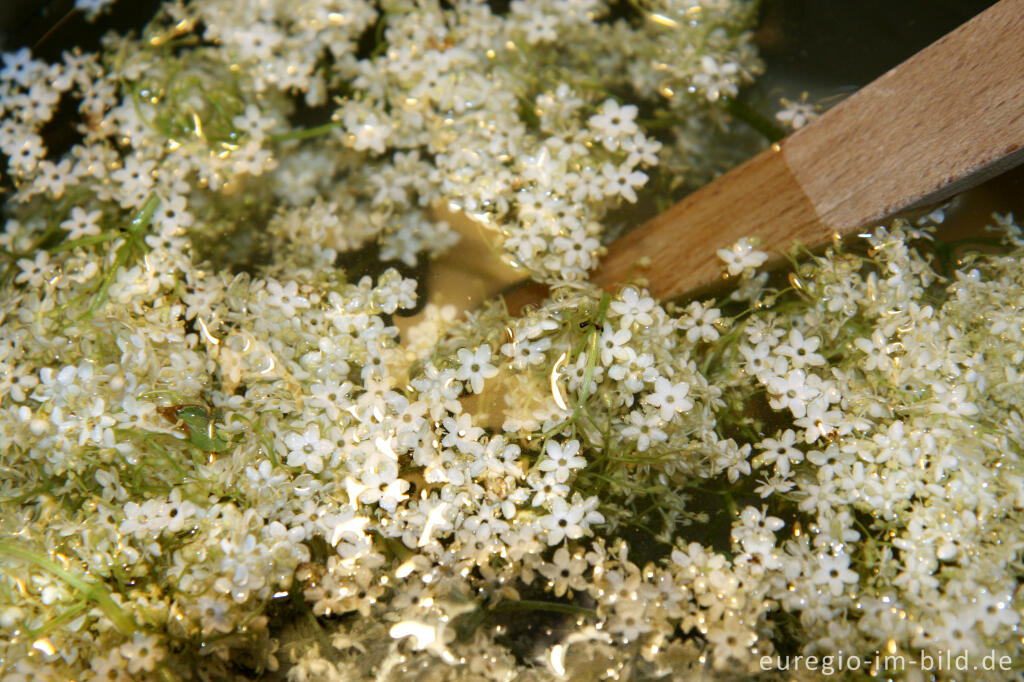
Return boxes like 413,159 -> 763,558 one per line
0,0 -> 1024,680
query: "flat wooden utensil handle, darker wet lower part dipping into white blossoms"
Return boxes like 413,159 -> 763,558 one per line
592,0 -> 1024,298
